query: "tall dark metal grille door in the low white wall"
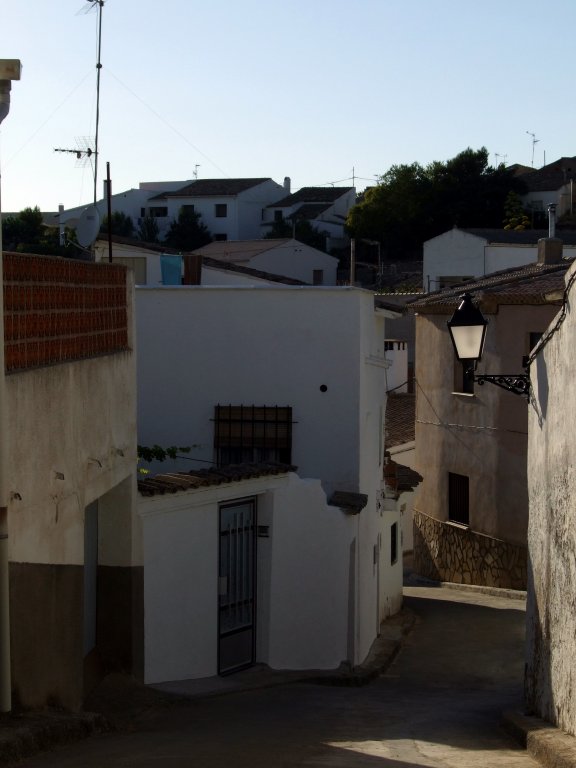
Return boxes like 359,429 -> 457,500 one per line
218,499 -> 256,674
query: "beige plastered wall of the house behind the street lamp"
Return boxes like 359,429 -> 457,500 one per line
415,306 -> 556,544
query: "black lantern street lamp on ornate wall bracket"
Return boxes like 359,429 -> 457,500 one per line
448,293 -> 530,397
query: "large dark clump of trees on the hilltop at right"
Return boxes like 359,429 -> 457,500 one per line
347,147 -> 524,258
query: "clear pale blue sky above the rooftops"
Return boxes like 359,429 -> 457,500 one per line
0,0 -> 576,211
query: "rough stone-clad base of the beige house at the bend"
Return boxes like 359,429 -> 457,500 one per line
414,510 -> 526,589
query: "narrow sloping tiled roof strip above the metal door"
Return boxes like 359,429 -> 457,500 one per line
138,464 -> 297,496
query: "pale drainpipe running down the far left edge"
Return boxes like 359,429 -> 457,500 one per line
0,59 -> 20,712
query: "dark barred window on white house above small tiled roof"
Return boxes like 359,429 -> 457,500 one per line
214,405 -> 293,467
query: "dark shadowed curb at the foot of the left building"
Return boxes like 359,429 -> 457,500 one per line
0,712 -> 112,766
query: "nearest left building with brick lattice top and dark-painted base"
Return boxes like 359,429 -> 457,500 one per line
0,253 -> 137,710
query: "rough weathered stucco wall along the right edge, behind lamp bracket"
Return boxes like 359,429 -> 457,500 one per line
526,266 -> 576,735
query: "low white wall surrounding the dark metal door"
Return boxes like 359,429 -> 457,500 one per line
139,473 -> 354,683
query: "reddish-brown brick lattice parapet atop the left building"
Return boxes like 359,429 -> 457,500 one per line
4,253 -> 128,373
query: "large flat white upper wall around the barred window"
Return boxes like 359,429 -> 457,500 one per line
136,286 -> 385,493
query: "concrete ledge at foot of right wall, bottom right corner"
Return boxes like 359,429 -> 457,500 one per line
503,712 -> 576,768
